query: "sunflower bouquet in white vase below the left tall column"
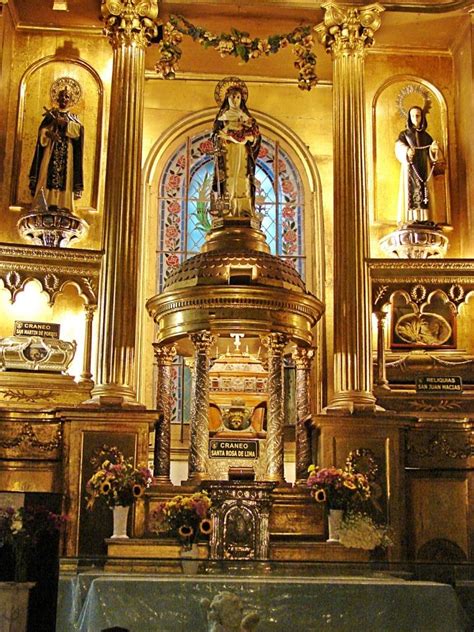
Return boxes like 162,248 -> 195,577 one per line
86,445 -> 153,509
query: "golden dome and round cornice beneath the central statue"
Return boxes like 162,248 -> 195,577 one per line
147,219 -> 324,345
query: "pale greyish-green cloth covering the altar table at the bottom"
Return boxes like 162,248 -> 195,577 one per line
56,573 -> 469,632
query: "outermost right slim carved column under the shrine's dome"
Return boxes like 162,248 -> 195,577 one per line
293,347 -> 314,482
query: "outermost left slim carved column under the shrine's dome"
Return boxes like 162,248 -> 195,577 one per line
153,343 -> 176,484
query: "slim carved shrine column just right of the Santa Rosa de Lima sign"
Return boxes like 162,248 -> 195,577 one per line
262,333 -> 288,481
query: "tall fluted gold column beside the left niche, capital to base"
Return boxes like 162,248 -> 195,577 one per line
93,0 -> 158,403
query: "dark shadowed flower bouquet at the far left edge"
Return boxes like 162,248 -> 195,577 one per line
0,507 -> 67,582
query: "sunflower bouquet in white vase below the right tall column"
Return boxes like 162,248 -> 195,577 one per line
306,465 -> 370,510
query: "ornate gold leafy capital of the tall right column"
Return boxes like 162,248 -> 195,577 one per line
315,0 -> 385,57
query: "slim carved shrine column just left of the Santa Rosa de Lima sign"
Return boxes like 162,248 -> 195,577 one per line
188,331 -> 214,481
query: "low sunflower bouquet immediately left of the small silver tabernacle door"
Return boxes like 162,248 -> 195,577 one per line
150,492 -> 212,549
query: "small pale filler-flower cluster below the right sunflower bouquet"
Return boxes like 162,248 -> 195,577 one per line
339,512 -> 393,551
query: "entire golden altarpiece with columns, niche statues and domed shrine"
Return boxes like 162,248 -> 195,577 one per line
0,0 -> 474,624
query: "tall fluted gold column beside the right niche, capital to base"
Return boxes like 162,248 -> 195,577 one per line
316,2 -> 383,412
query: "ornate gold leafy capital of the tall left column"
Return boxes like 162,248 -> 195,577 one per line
100,0 -> 158,49
